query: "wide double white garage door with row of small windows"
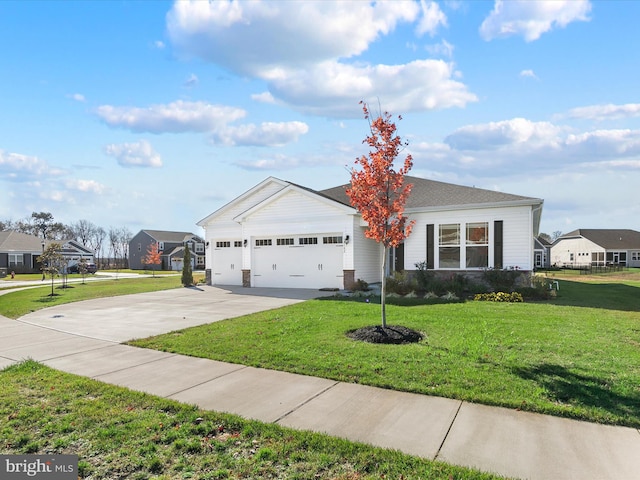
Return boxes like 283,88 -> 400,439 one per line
252,233 -> 344,288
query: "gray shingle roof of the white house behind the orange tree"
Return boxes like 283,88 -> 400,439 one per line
318,176 -> 542,209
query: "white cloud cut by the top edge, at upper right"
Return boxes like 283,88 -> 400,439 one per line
480,0 -> 591,42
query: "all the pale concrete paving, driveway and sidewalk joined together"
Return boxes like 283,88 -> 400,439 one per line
0,287 -> 640,480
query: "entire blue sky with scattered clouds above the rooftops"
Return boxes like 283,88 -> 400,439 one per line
0,0 -> 640,237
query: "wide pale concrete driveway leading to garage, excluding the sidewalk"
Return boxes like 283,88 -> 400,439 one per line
12,286 -> 333,343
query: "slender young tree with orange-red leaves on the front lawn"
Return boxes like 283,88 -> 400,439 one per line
346,102 -> 415,328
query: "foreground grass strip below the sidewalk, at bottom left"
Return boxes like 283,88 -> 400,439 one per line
0,360 -> 499,480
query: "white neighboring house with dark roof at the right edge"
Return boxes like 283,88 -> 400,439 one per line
551,228 -> 640,268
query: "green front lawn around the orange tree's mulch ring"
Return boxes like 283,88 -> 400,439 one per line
131,278 -> 640,427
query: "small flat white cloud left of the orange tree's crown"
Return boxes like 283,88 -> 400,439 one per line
211,122 -> 309,147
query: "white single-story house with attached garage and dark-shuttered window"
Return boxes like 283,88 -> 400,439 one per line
198,177 -> 543,289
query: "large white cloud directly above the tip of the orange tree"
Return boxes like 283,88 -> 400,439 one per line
271,59 -> 477,118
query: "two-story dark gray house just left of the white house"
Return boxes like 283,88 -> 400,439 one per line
129,230 -> 205,271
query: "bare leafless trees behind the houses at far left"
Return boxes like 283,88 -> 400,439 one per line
0,212 -> 133,269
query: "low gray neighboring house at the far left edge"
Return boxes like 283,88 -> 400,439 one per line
0,230 -> 93,273
